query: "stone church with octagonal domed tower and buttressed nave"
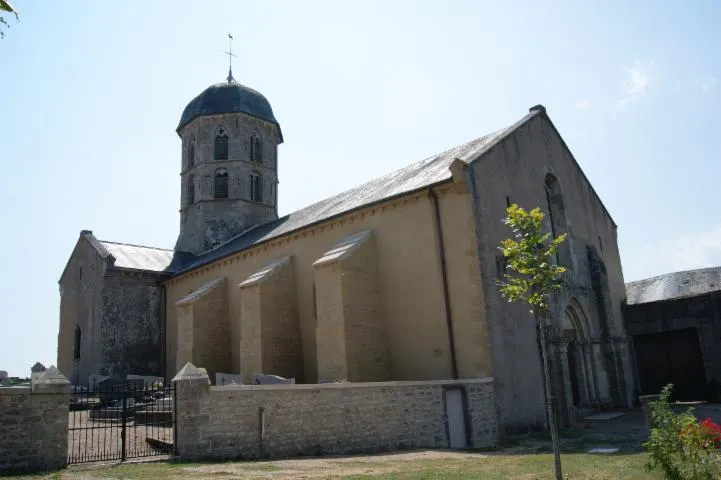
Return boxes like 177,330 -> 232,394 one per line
58,68 -> 633,430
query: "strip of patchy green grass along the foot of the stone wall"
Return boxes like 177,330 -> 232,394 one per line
2,453 -> 661,480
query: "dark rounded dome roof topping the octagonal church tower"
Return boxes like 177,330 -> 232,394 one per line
176,77 -> 280,133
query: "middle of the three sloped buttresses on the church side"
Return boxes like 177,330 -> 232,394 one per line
238,256 -> 304,383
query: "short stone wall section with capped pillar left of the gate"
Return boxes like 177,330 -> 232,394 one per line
0,367 -> 70,474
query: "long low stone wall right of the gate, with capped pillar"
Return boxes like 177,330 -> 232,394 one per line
174,364 -> 497,460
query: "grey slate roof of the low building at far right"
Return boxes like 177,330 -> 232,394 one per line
626,267 -> 721,305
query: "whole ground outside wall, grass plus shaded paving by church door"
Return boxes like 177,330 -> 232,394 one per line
10,404 -> 721,480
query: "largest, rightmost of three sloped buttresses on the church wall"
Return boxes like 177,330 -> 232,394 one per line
313,230 -> 391,382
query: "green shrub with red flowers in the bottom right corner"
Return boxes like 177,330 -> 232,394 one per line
643,385 -> 721,480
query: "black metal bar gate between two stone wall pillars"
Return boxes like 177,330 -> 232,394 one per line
68,379 -> 175,463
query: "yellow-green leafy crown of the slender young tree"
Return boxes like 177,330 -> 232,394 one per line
498,203 -> 566,314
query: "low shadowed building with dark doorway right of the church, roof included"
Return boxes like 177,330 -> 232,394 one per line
625,267 -> 721,401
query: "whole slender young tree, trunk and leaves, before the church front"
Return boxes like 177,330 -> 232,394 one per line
498,203 -> 566,480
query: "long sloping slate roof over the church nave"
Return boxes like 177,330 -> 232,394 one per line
176,112 -> 524,273
